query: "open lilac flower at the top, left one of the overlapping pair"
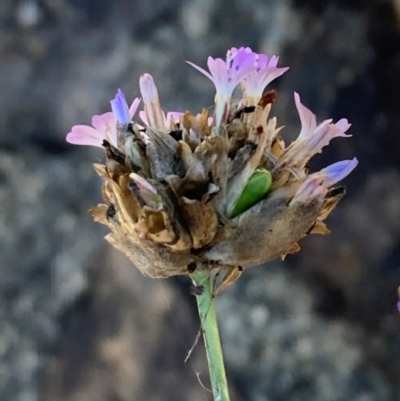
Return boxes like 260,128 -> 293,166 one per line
187,48 -> 256,126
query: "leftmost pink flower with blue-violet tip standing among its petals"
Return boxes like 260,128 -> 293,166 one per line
66,90 -> 140,147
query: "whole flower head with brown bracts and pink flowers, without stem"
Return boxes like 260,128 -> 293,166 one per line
67,47 -> 357,284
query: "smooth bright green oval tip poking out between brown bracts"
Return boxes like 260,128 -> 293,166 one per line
230,168 -> 272,219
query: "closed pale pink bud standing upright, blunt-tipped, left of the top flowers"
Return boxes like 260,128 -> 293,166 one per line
139,74 -> 164,130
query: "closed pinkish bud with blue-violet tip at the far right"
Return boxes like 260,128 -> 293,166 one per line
290,158 -> 358,205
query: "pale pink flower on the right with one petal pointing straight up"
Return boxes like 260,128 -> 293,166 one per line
275,92 -> 351,170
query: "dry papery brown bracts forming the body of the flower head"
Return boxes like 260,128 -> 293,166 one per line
90,93 -> 344,277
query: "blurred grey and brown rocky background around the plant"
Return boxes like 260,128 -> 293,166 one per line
0,0 -> 400,401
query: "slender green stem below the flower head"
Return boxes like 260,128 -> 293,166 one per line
190,263 -> 229,401
